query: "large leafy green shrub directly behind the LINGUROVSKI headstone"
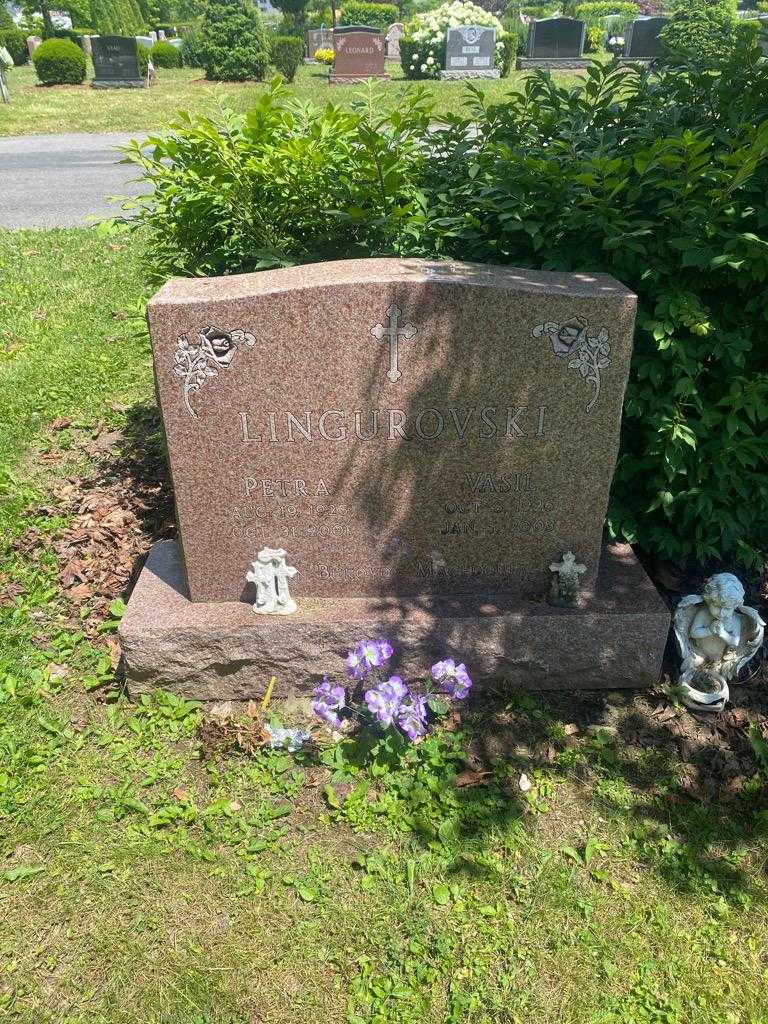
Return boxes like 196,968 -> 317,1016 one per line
128,54 -> 768,565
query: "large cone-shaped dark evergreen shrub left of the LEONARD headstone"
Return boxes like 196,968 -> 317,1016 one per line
200,0 -> 269,82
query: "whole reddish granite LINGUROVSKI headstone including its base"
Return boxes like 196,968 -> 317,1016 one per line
121,259 -> 669,699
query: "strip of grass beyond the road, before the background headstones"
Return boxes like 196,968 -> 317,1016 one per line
0,63 -> 593,135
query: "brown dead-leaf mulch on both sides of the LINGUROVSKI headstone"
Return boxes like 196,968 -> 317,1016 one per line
0,406 -> 768,801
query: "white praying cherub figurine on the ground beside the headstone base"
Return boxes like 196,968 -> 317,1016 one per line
674,572 -> 765,711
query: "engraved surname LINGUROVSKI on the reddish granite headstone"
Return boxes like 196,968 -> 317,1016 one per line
240,406 -> 547,444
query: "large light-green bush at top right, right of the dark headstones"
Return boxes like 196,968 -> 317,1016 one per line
660,0 -> 736,65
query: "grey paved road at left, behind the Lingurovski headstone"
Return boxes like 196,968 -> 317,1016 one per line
0,133 -> 149,227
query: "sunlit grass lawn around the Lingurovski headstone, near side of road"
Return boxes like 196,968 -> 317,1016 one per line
0,232 -> 768,1024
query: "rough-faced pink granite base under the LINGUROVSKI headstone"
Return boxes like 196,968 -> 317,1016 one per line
120,541 -> 670,700
